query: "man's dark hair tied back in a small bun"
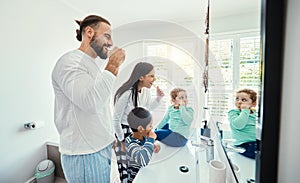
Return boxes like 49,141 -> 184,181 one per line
75,15 -> 110,41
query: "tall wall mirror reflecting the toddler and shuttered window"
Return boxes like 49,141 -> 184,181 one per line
208,0 -> 262,182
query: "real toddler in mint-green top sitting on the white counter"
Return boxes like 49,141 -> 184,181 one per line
155,88 -> 194,147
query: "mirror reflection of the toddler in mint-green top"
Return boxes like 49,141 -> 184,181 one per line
228,89 -> 257,159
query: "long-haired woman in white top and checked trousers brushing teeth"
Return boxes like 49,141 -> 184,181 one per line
113,62 -> 164,182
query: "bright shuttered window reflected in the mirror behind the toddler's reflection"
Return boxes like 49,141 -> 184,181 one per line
208,33 -> 261,123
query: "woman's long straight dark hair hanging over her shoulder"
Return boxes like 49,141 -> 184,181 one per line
114,62 -> 154,107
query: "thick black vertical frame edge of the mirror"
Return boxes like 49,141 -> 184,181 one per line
255,0 -> 286,183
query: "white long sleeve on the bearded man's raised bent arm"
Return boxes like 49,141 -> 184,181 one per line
53,55 -> 116,113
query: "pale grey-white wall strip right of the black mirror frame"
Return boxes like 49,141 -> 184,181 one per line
278,0 -> 300,183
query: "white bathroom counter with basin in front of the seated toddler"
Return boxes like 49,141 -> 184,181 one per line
134,143 -> 208,183
